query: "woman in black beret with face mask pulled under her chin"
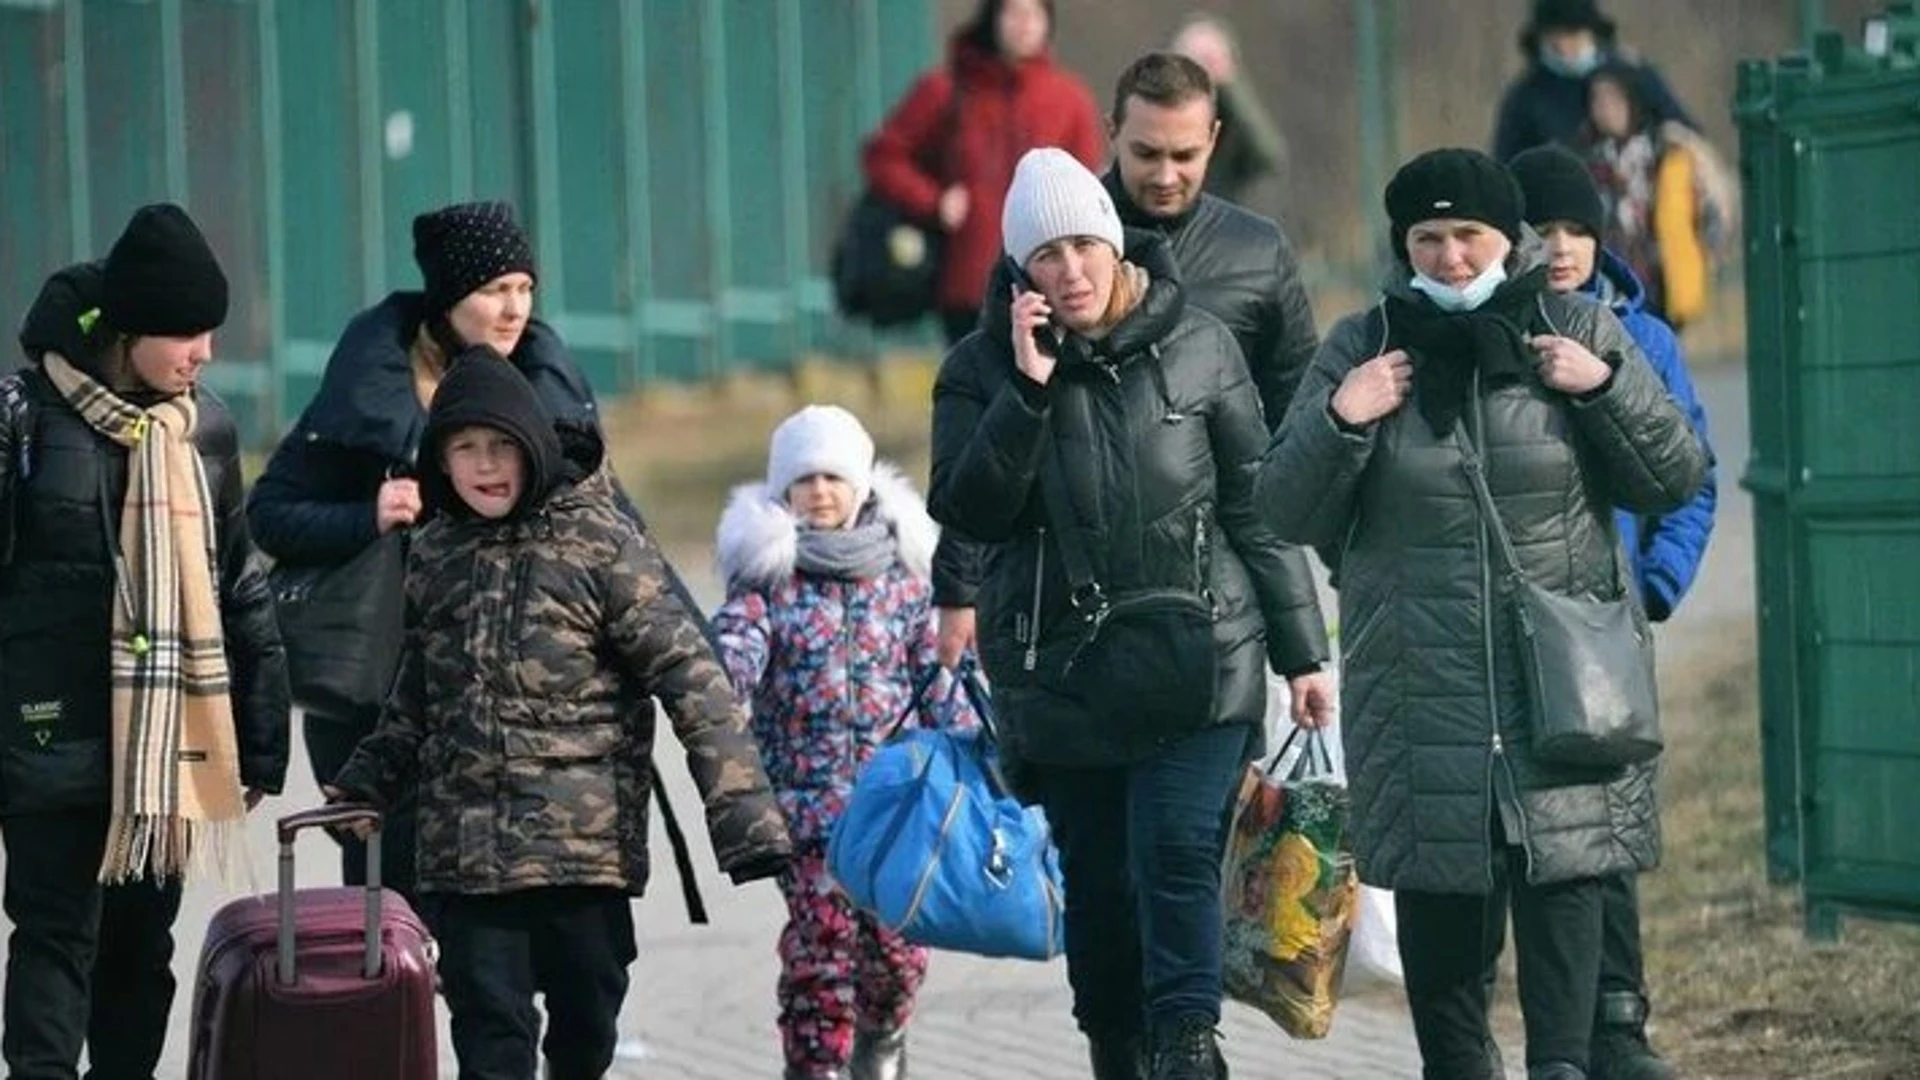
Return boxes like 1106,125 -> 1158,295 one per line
1260,150 -> 1707,1080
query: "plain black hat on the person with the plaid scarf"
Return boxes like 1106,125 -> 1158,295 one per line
100,202 -> 227,338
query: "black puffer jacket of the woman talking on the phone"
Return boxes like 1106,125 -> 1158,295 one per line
929,231 -> 1327,765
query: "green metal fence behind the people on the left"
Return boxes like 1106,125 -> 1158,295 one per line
0,0 -> 935,438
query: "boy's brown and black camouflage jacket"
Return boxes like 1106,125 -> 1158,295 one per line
334,446 -> 791,894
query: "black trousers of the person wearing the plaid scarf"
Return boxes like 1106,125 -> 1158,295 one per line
0,807 -> 180,1080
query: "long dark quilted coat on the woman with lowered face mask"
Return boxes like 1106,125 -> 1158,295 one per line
1260,261 -> 1707,894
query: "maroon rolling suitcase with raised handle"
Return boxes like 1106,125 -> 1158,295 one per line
186,805 -> 440,1080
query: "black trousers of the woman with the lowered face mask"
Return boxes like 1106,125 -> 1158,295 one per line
1394,844 -> 1605,1080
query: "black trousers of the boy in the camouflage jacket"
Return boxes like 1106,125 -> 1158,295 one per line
422,888 -> 636,1080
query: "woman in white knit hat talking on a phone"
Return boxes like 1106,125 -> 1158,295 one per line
929,148 -> 1331,1080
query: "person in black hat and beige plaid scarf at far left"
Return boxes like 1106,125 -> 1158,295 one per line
0,206 -> 288,1078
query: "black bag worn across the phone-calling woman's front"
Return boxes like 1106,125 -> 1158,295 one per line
1033,461 -> 1215,755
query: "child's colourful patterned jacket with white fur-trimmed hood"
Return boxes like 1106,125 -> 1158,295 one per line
712,463 -> 962,847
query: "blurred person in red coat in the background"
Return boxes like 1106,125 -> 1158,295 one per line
864,0 -> 1106,344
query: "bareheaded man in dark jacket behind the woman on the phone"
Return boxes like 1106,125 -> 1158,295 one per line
933,52 -> 1319,676
